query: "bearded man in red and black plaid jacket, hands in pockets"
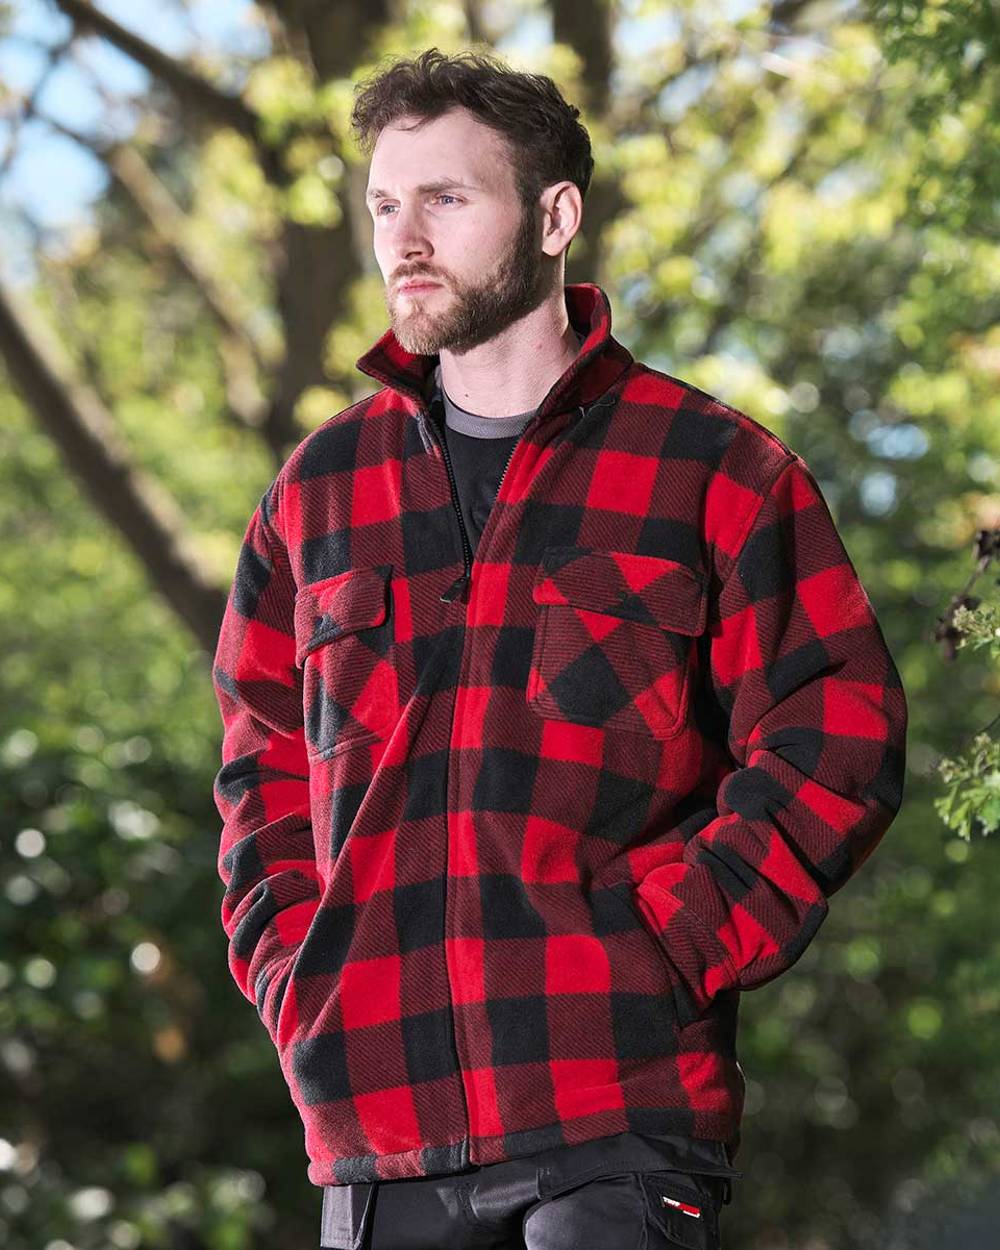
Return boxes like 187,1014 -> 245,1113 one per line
214,49 -> 906,1250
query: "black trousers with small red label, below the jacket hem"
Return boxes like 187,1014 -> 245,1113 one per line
320,1154 -> 741,1250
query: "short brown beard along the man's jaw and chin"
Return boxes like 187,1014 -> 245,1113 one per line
386,206 -> 554,356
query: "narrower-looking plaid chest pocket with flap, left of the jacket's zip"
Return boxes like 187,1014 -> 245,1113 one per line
295,565 -> 399,759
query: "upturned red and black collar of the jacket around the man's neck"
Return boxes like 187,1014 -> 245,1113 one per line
355,283 -> 633,413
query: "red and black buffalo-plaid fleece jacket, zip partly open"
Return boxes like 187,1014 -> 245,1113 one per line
214,284 -> 906,1185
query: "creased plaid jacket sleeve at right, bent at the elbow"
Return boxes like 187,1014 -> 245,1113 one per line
634,456 -> 908,1025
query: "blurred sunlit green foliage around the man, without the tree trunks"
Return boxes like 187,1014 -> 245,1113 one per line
0,3 -> 1000,1250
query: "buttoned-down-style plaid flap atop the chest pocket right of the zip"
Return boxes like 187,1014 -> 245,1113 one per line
531,546 -> 709,634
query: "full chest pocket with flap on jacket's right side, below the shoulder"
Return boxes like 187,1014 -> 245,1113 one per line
526,546 -> 708,738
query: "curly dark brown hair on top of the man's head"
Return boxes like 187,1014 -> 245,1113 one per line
350,48 -> 594,209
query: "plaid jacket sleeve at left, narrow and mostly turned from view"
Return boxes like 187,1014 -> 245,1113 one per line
213,482 -> 321,1038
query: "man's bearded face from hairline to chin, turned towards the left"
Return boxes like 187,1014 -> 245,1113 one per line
369,109 -> 553,355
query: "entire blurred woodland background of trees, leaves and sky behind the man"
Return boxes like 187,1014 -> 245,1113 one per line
0,0 -> 1000,1250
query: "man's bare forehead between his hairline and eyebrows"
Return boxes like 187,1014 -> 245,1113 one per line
369,109 -> 514,190
